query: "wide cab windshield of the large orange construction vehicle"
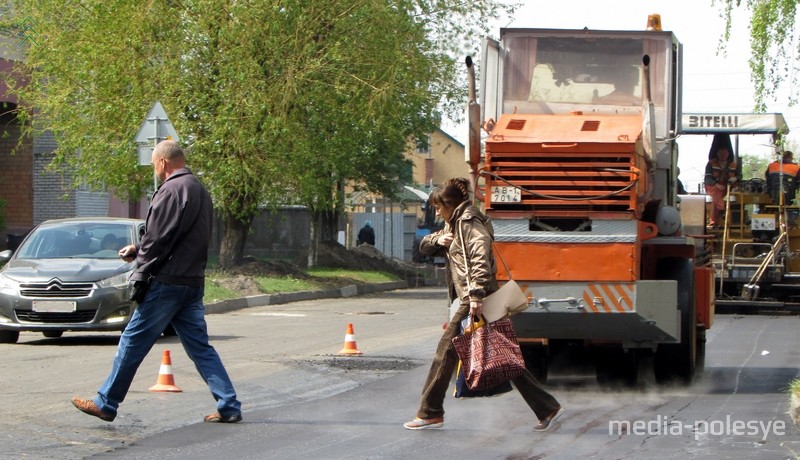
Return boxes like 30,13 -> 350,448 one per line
503,33 -> 669,113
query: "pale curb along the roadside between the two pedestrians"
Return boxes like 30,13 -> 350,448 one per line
206,281 -> 409,315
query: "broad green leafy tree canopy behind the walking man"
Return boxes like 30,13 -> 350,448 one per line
5,0 -> 508,268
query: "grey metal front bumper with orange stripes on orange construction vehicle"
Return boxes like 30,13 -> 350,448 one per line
512,280 -> 681,347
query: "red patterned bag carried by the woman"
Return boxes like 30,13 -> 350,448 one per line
453,318 -> 525,390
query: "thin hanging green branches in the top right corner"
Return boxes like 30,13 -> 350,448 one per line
712,0 -> 800,112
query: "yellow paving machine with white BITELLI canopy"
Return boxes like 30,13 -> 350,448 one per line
681,113 -> 800,313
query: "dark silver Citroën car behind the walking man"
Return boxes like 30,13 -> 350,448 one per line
0,217 -> 144,343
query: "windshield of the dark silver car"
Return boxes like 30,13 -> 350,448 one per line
16,222 -> 134,259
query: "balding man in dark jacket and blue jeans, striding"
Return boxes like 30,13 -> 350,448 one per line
72,141 -> 242,423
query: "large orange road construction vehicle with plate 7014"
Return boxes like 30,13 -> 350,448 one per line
467,18 -> 714,383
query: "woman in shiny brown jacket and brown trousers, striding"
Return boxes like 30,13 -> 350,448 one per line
403,177 -> 564,431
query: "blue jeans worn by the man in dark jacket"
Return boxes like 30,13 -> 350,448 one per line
94,281 -> 241,417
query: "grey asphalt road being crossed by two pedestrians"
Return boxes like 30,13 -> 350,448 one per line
0,288 -> 800,460
